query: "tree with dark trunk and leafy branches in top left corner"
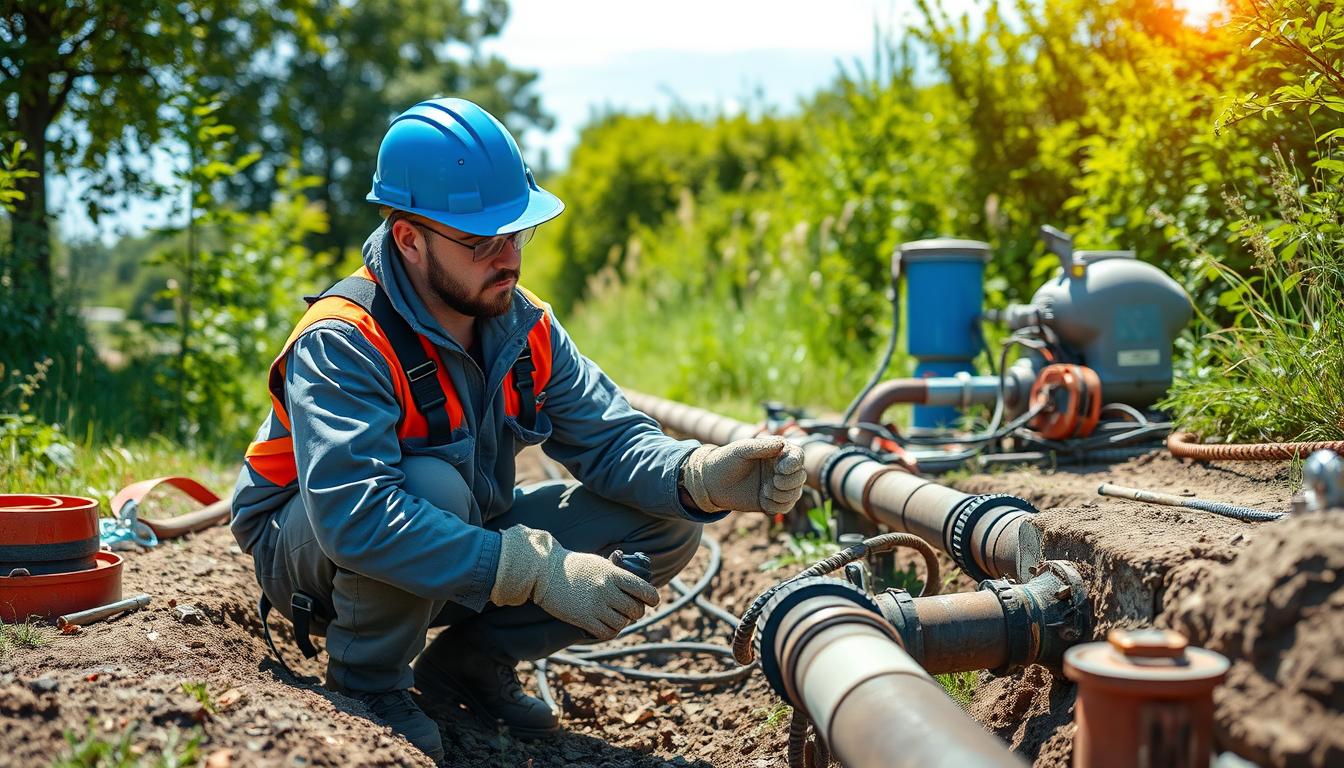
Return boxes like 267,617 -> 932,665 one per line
0,0 -> 317,315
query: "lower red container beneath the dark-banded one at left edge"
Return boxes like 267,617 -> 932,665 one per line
0,551 -> 121,623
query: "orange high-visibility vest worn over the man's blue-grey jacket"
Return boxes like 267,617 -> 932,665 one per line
245,266 -> 551,487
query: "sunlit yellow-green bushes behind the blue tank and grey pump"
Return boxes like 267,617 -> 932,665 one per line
542,0 -> 1344,433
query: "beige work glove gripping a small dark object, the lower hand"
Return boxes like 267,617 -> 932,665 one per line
491,526 -> 659,640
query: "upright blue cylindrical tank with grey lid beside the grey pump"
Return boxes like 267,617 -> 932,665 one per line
891,238 -> 989,430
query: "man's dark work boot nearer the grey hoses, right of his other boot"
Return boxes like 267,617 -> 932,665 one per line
414,632 -> 560,738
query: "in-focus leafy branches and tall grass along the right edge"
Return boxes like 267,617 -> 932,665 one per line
1163,0 -> 1344,441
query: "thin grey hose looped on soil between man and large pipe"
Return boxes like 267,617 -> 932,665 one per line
535,537 -> 754,710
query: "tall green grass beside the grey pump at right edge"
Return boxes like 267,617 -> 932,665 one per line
1160,149 -> 1344,441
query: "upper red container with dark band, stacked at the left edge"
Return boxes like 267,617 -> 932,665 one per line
0,494 -> 98,576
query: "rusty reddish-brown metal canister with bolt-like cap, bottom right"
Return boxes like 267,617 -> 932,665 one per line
1064,629 -> 1228,768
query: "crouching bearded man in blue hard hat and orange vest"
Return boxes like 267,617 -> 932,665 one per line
233,98 -> 805,760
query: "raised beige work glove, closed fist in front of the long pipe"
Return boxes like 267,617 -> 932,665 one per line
681,437 -> 808,514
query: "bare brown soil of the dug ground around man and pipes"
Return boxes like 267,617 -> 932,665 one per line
0,453 -> 1344,768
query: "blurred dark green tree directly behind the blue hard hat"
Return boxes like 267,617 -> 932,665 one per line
215,0 -> 552,257
